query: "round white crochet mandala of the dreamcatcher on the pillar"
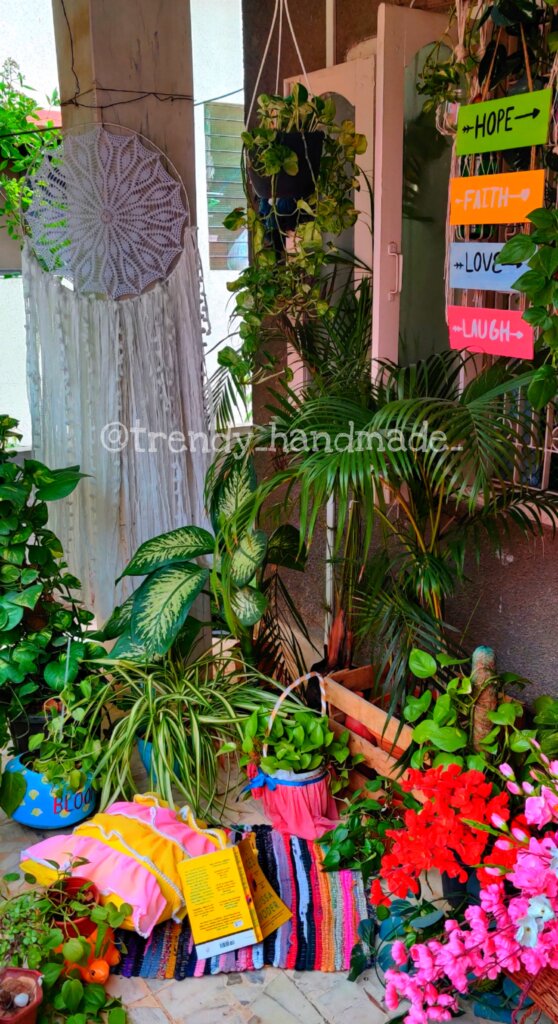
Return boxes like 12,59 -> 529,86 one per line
26,125 -> 188,299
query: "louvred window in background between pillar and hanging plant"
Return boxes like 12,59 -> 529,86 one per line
205,102 -> 248,270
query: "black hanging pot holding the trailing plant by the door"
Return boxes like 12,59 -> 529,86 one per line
248,131 -> 324,199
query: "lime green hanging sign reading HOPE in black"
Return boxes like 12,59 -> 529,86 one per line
456,89 -> 552,157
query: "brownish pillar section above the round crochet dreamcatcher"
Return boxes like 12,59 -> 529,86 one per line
52,0 -> 196,222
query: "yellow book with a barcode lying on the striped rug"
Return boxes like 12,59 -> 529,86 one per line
178,836 -> 292,959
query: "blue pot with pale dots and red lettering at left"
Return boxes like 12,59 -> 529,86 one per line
4,757 -> 96,829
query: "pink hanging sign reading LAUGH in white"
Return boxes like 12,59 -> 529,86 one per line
447,306 -> 533,359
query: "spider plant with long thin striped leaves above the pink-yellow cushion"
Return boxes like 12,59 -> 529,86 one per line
90,653 -> 280,818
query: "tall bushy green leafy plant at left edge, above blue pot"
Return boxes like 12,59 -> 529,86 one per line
0,416 -> 93,752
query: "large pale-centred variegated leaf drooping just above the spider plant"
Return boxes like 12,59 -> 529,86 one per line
132,563 -> 209,654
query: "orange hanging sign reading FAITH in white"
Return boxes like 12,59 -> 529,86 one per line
449,171 -> 545,224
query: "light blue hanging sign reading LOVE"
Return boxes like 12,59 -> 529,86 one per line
449,242 -> 529,292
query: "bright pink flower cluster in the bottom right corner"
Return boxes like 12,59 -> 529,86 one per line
386,756 -> 558,1024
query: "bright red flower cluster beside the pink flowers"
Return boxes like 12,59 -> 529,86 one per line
380,765 -> 509,898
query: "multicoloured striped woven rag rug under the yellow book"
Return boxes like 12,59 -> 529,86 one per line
116,825 -> 368,980
